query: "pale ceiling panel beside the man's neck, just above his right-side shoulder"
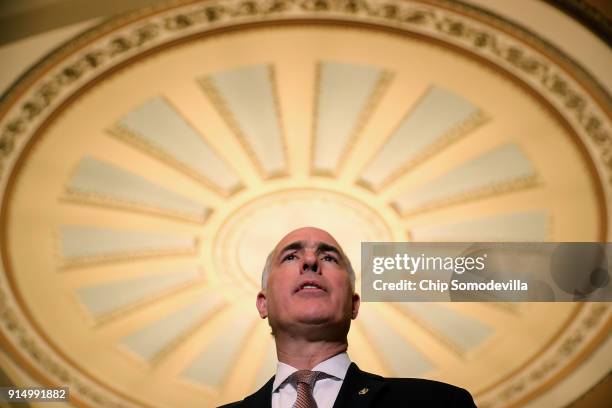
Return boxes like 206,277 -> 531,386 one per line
359,308 -> 434,377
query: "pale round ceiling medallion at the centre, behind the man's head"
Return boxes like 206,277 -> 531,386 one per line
212,188 -> 395,295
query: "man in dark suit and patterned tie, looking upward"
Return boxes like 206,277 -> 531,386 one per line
224,227 -> 475,408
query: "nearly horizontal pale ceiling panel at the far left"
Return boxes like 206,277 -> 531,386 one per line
60,226 -> 197,261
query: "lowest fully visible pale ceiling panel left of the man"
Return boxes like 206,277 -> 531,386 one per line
182,318 -> 253,387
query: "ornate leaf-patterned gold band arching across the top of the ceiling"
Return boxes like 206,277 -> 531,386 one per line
0,0 -> 612,189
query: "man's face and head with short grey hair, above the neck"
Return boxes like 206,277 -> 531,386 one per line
257,227 -> 359,336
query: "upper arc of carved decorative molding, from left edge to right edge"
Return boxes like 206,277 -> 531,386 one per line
0,0 -> 612,190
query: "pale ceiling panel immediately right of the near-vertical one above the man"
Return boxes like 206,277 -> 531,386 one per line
360,86 -> 482,190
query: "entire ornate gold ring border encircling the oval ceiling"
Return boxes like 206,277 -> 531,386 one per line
0,0 -> 612,407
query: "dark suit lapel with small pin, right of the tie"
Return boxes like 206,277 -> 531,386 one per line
334,363 -> 385,408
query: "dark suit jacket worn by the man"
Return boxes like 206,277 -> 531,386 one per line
221,363 -> 476,408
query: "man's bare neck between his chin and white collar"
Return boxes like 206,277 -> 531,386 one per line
275,336 -> 348,370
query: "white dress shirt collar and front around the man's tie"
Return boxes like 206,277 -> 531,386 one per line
272,353 -> 351,408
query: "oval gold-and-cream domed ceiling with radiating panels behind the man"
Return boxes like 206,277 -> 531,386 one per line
0,0 -> 612,407
